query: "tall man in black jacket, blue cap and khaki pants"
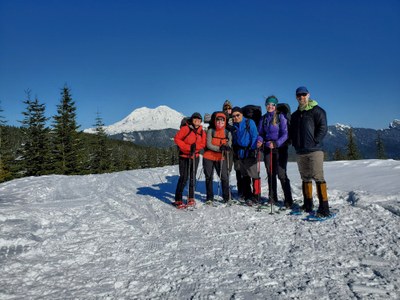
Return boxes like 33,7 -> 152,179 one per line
290,86 -> 330,217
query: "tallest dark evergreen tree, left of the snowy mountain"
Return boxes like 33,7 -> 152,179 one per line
53,86 -> 82,175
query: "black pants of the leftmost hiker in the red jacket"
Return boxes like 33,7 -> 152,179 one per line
175,157 -> 199,201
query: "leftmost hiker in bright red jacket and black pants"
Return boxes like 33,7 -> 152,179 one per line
174,112 -> 206,208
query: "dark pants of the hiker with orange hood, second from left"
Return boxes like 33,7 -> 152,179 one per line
203,158 -> 229,201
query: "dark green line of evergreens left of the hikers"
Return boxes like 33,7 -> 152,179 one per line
0,86 -> 178,182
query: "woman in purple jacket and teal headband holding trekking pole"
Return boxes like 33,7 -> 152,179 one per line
257,96 -> 293,208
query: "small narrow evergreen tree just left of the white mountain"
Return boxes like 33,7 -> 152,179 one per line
90,113 -> 111,173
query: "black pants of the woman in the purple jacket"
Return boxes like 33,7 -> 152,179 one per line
264,146 -> 293,204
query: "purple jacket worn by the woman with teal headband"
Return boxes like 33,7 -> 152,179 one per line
257,112 -> 288,147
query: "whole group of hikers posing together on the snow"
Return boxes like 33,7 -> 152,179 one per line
174,86 -> 330,217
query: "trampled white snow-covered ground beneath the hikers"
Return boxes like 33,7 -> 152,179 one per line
0,160 -> 400,299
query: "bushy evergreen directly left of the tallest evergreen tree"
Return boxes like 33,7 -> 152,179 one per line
21,90 -> 50,176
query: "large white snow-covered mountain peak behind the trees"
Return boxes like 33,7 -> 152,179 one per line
84,105 -> 183,135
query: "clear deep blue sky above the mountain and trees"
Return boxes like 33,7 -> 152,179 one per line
0,0 -> 400,129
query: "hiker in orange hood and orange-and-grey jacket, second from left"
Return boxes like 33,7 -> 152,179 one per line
203,111 -> 232,204
